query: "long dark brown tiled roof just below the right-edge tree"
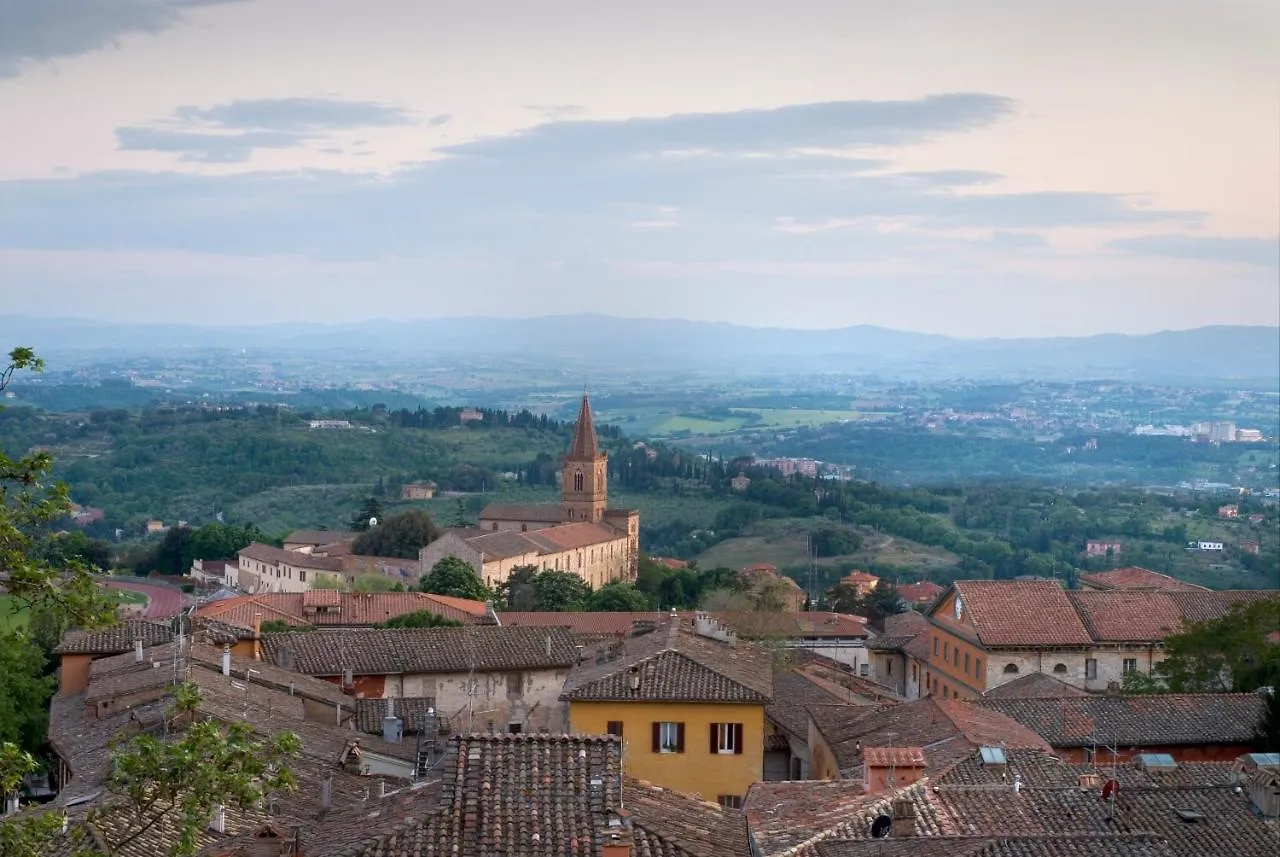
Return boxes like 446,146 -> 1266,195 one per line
975,693 -> 1265,747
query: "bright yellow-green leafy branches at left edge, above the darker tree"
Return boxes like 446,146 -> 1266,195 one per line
0,348 -> 115,628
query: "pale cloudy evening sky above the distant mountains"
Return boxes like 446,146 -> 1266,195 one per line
0,0 -> 1280,336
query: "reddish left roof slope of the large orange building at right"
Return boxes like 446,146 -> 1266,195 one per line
952,581 -> 1093,647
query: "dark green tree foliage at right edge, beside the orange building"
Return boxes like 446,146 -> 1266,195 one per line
1125,595 -> 1280,693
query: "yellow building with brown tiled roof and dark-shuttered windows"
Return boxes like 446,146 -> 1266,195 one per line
561,615 -> 773,807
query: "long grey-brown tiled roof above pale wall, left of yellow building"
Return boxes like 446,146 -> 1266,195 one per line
262,625 -> 577,675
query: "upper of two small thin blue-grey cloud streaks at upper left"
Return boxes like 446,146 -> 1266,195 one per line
174,98 -> 414,132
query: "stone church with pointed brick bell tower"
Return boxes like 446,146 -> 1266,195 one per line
419,394 -> 640,588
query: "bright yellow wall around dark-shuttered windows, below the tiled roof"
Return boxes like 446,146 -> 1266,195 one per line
568,702 -> 764,801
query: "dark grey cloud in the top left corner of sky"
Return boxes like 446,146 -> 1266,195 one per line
0,0 -> 242,78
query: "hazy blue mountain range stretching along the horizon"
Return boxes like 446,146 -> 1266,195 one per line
0,315 -> 1280,388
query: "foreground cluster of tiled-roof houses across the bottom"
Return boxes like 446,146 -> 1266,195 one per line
17,569 -> 1280,857
